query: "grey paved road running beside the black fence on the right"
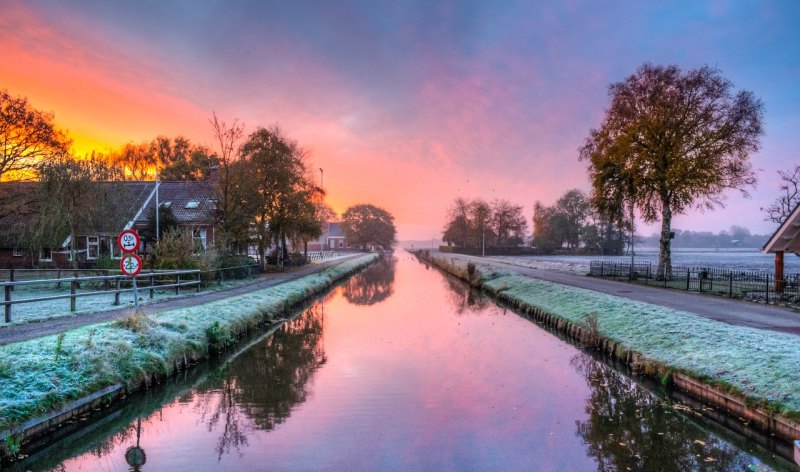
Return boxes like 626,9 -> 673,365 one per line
446,255 -> 800,336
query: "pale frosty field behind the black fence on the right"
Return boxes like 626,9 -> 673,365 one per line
492,248 -> 800,274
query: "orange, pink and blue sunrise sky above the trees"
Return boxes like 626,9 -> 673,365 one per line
0,0 -> 800,240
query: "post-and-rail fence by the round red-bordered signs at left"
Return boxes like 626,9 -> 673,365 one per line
0,270 -> 201,323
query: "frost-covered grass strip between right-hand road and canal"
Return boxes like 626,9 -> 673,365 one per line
422,255 -> 800,417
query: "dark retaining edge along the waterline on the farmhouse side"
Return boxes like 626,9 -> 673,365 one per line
0,255 -> 377,460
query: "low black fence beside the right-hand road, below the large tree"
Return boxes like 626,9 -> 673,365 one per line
589,261 -> 800,305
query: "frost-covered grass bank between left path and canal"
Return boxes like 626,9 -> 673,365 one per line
0,254 -> 377,431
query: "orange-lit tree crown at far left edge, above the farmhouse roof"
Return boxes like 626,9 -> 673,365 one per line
0,90 -> 70,180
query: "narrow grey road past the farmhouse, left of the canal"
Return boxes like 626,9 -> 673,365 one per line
0,254 -> 361,345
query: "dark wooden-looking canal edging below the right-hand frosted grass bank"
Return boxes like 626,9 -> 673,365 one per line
416,251 -> 800,450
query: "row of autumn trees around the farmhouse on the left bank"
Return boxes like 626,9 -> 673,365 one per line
0,87 -> 396,261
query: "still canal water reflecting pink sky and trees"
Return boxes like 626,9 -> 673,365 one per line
12,251 -> 792,472
